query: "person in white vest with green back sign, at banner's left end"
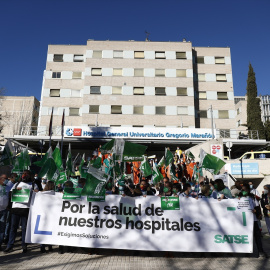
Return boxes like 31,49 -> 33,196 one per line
4,170 -> 38,253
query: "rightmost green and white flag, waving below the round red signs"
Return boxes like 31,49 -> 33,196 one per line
200,149 -> 226,175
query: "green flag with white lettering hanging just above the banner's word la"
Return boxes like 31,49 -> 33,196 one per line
82,174 -> 106,202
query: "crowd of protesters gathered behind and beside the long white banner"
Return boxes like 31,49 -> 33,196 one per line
0,148 -> 270,257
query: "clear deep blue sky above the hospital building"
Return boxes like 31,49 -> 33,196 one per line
0,0 -> 270,99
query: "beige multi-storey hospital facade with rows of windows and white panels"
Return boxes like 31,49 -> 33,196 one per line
39,40 -> 236,136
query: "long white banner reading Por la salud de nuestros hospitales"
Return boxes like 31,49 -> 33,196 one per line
26,192 -> 253,253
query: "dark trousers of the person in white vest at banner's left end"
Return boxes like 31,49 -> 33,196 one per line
7,214 -> 28,248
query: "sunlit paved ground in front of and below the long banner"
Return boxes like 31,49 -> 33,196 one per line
0,221 -> 270,270
